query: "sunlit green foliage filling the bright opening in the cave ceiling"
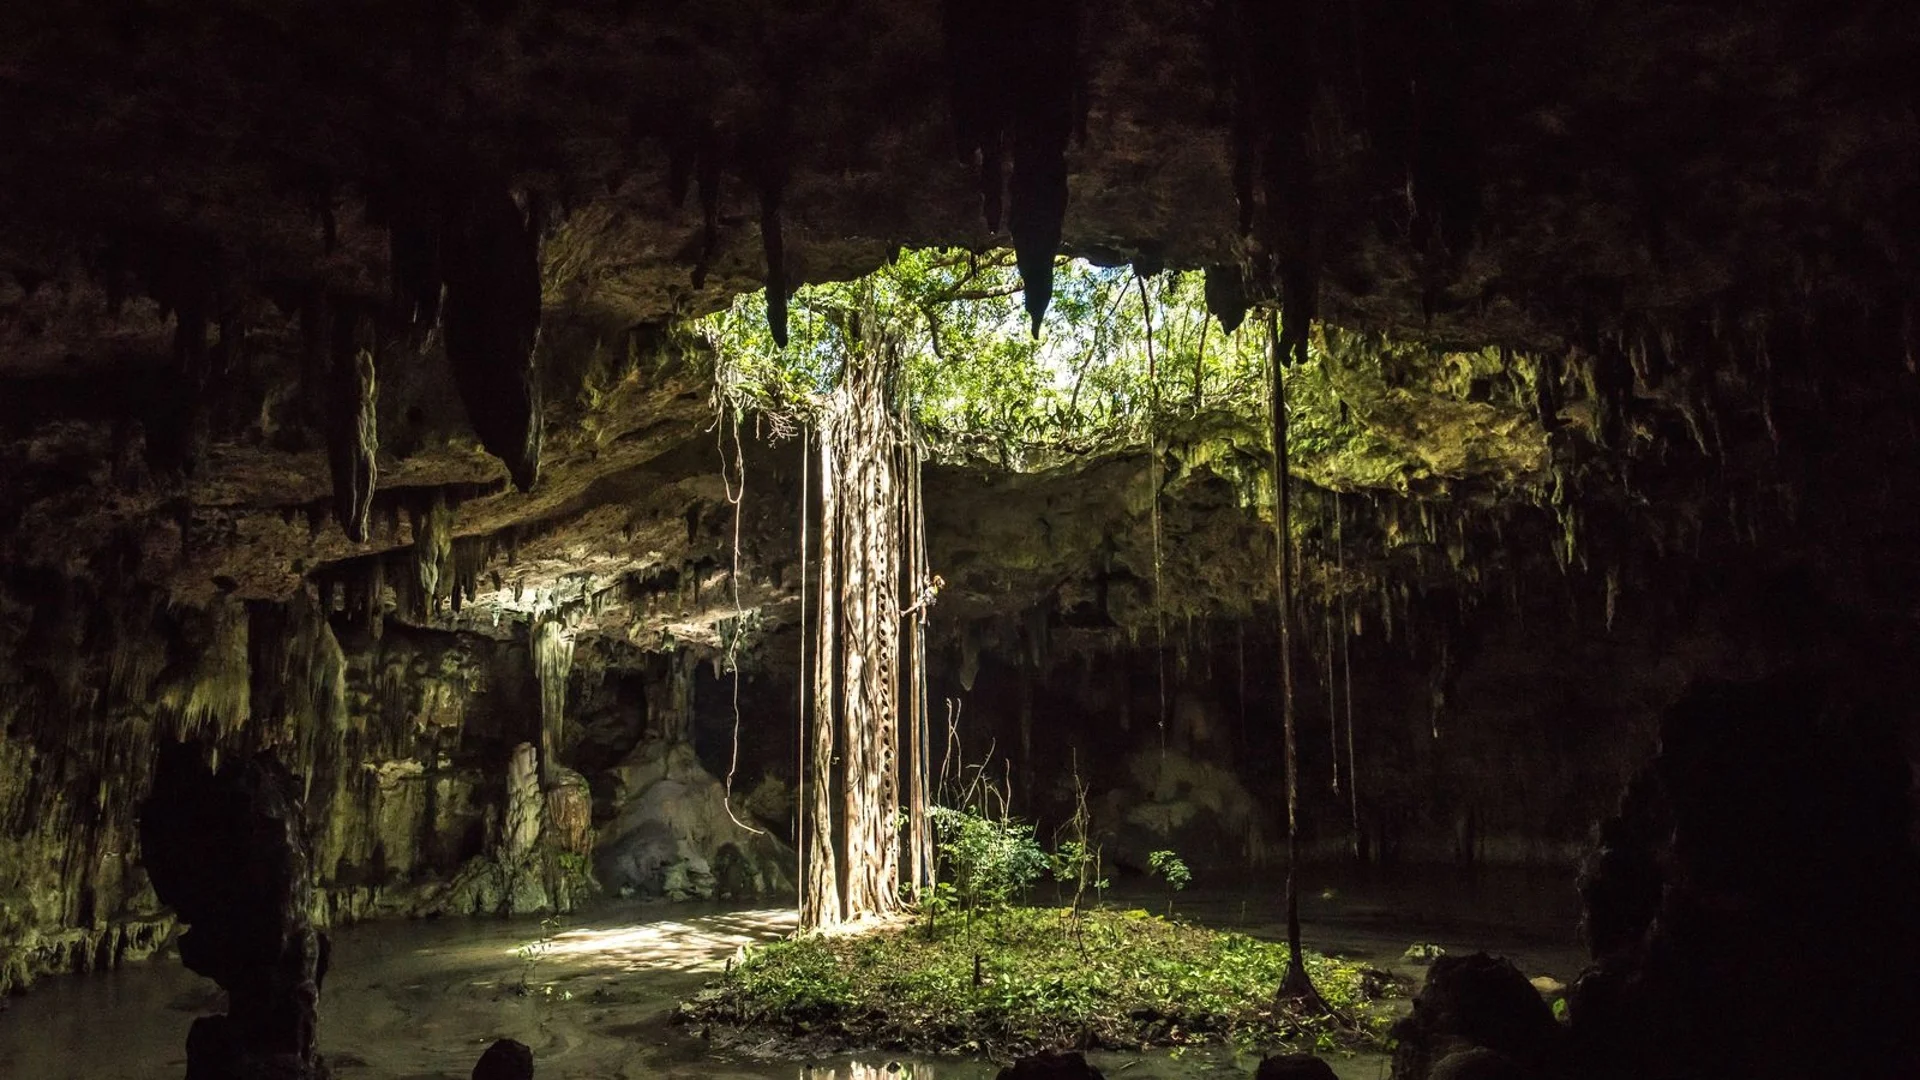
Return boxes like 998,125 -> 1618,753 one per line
703,250 -> 1265,469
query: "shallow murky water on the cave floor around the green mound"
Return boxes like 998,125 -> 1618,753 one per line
0,871 -> 1582,1080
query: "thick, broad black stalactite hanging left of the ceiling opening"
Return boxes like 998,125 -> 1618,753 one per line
444,183 -> 543,492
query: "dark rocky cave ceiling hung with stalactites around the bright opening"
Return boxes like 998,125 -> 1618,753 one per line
0,0 -> 1920,648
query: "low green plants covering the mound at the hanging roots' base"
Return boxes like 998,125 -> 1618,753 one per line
682,907 -> 1398,1055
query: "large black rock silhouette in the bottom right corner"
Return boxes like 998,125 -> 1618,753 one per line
1569,668 -> 1920,1078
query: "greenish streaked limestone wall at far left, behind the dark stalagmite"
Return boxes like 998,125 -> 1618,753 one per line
0,582 -> 552,986
